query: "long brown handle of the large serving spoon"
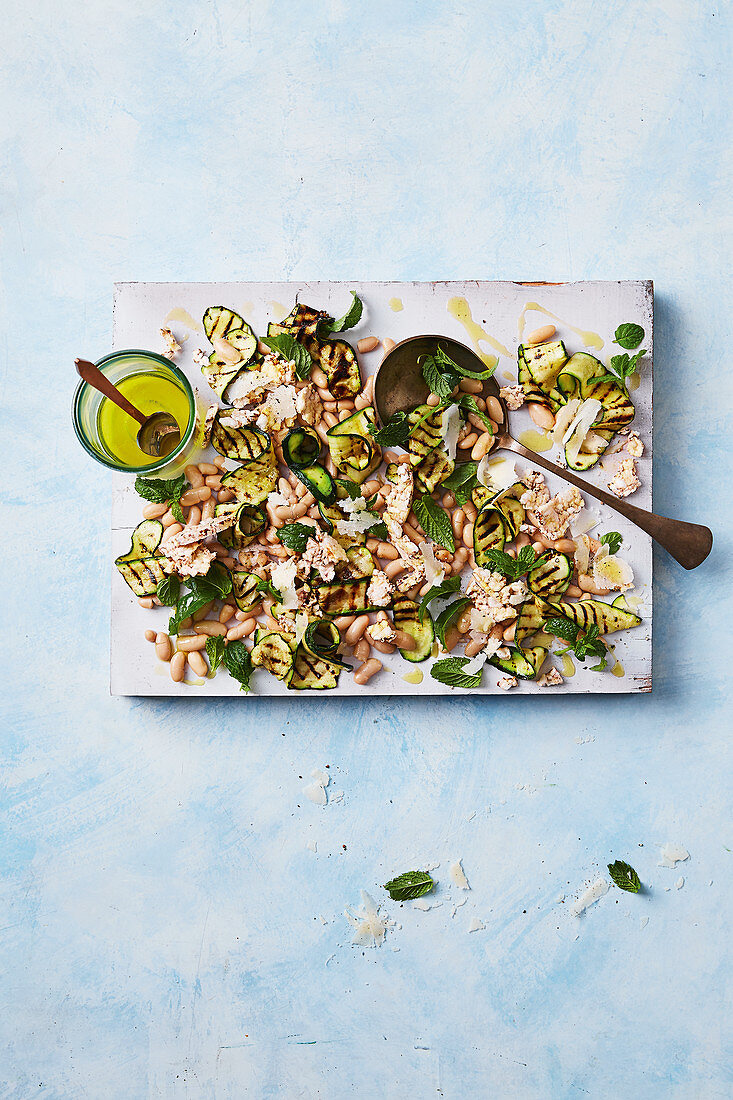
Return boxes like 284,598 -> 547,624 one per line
499,436 -> 712,569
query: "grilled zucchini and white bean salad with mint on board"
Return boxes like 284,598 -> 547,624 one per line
116,294 -> 644,691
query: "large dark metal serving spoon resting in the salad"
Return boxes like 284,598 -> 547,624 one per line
374,336 -> 712,569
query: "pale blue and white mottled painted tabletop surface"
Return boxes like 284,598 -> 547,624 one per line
0,0 -> 733,1100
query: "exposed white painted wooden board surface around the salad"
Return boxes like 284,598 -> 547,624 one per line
110,281 -> 653,700
